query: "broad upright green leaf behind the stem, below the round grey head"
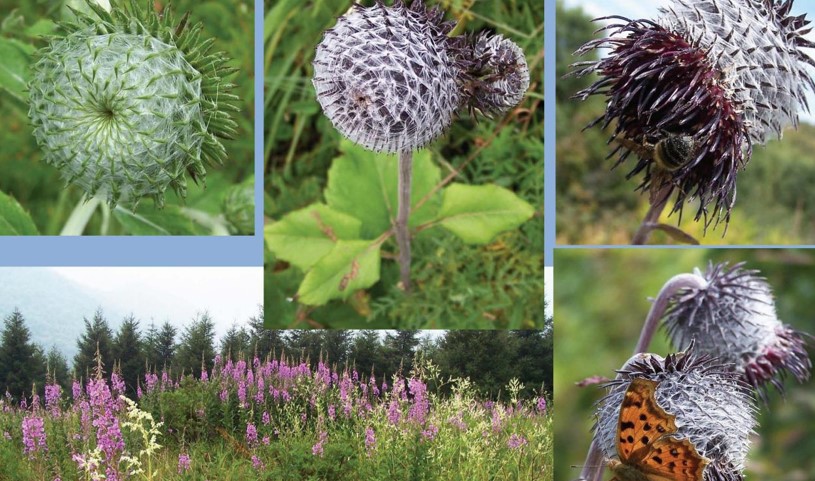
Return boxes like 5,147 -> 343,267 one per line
325,140 -> 441,239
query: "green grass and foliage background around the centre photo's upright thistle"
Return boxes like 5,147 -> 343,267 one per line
264,0 -> 545,329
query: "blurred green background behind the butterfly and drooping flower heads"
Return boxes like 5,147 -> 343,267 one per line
553,249 -> 815,481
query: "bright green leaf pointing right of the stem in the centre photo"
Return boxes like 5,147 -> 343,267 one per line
439,184 -> 535,244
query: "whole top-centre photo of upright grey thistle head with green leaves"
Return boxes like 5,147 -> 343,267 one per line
264,0 -> 545,329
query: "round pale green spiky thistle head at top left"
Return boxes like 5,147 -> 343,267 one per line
28,0 -> 237,208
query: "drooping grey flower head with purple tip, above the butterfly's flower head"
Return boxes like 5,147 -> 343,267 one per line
664,263 -> 812,394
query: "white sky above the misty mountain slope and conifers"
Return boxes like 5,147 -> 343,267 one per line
48,267 -> 263,331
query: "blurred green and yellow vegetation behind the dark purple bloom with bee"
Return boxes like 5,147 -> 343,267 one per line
556,1 -> 815,245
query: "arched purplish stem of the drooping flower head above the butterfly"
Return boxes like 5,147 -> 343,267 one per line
579,274 -> 708,481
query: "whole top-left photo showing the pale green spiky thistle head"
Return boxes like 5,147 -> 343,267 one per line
0,0 -> 255,236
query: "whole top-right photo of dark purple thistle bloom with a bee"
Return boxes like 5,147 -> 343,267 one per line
551,0 -> 815,245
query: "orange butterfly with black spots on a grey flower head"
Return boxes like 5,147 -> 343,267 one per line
608,378 -> 710,481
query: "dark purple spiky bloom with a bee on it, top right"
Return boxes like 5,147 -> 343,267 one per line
576,18 -> 751,225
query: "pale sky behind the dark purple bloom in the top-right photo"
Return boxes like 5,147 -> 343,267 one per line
564,0 -> 815,124
